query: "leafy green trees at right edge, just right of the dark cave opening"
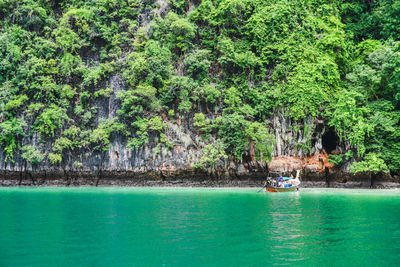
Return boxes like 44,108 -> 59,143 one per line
327,41 -> 400,170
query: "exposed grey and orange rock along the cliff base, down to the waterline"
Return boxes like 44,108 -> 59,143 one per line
0,98 -> 399,188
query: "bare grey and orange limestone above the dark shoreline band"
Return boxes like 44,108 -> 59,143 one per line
0,75 -> 330,175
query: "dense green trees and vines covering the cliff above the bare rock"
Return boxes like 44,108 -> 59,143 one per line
0,0 -> 400,175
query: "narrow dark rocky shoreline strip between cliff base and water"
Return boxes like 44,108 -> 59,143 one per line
0,170 -> 400,189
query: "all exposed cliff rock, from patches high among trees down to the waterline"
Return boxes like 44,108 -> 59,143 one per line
0,0 -> 398,187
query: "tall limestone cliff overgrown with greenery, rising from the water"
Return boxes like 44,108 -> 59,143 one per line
0,0 -> 400,187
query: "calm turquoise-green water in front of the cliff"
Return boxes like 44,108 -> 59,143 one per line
0,188 -> 400,266
